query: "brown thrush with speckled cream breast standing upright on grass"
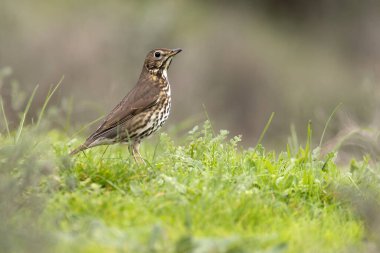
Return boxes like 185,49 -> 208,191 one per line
70,48 -> 182,164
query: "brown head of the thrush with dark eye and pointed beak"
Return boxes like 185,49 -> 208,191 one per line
144,48 -> 182,75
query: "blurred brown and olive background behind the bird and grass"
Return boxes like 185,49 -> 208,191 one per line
0,0 -> 380,150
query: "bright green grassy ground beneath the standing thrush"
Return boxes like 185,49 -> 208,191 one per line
0,118 -> 380,253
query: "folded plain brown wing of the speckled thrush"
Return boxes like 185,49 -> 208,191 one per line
86,82 -> 160,145
